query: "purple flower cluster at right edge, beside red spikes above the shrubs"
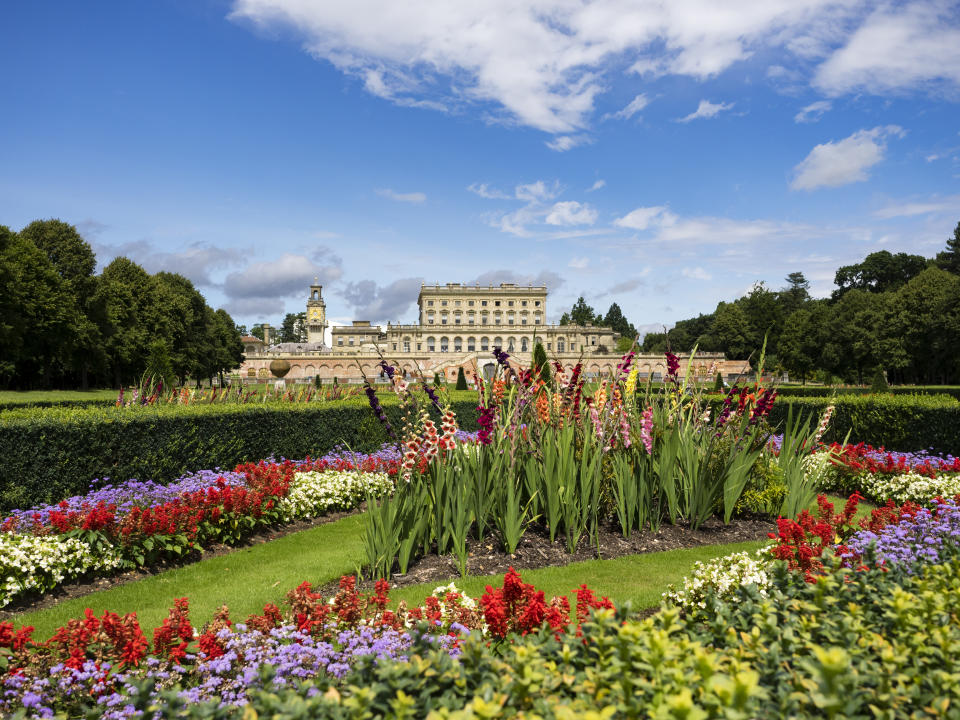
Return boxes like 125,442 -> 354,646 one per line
845,502 -> 960,572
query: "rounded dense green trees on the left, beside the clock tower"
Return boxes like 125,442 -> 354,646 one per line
0,220 -> 243,389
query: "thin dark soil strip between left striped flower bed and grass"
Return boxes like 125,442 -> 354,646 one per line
0,503 -> 366,620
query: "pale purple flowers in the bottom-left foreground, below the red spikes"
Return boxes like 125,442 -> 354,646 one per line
0,624 -> 470,720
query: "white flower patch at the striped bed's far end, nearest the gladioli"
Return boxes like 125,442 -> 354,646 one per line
278,470 -> 393,522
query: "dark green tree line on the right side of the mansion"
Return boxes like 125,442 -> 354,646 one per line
642,223 -> 960,384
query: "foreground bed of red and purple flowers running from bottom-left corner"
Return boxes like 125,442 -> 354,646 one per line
0,570 -> 612,719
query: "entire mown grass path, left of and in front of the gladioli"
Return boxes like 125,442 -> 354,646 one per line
15,496 -> 873,638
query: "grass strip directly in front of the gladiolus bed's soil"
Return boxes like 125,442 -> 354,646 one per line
390,541 -> 766,610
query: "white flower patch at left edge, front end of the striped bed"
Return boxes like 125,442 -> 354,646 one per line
0,533 -> 121,607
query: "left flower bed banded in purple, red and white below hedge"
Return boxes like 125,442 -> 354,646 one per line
0,444 -> 420,607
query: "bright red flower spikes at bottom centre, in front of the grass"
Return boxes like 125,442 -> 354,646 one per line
480,568 -> 613,640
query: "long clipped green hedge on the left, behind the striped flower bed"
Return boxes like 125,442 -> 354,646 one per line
0,391 -> 477,511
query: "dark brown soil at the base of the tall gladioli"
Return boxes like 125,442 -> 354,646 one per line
322,517 -> 776,595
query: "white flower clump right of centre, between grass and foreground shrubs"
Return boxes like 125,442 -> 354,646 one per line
663,548 -> 770,612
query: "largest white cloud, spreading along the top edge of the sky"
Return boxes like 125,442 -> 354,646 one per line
230,0 -> 880,136
